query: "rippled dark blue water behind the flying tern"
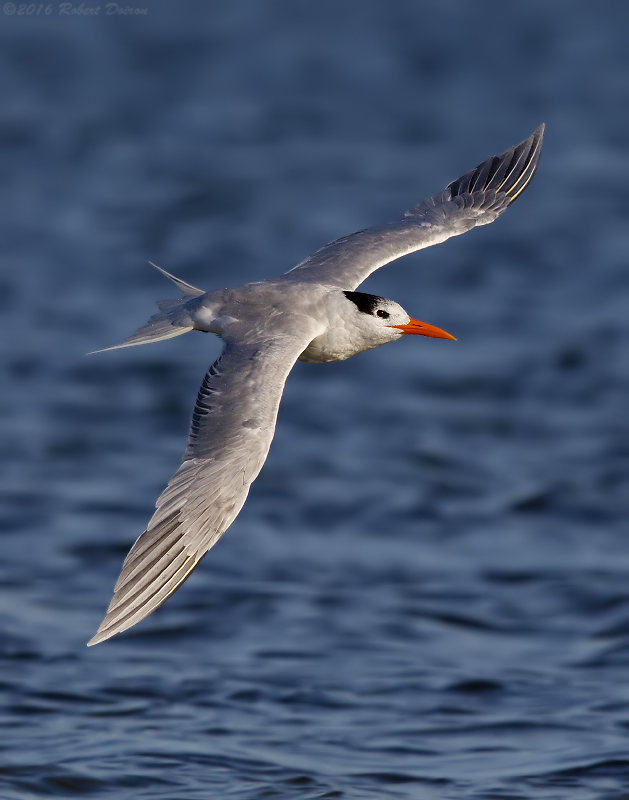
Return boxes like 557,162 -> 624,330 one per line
0,0 -> 629,800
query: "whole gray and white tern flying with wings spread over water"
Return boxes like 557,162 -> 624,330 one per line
89,125 -> 544,645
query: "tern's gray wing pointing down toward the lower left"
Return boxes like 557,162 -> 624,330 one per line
89,324 -> 313,645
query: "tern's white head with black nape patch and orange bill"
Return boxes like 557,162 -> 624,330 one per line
343,292 -> 456,347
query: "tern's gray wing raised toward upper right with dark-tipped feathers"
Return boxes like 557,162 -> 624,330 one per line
286,125 -> 544,290
